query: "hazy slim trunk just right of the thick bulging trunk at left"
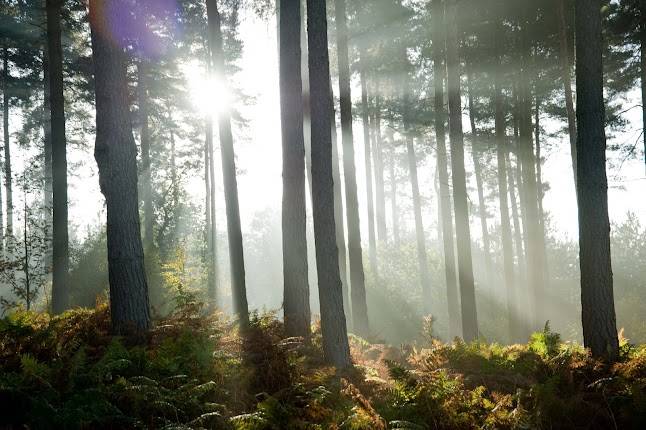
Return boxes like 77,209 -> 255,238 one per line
137,60 -> 154,251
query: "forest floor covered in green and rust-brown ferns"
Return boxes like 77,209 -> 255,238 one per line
0,303 -> 646,430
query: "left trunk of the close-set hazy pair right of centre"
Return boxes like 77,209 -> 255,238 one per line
431,0 -> 462,339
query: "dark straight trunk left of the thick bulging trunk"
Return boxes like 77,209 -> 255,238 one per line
46,0 -> 70,314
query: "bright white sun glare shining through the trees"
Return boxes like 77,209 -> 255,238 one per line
183,61 -> 231,117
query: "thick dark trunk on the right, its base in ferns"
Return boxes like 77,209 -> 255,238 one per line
575,0 -> 619,360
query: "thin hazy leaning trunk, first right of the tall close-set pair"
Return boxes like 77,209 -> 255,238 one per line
467,73 -> 494,288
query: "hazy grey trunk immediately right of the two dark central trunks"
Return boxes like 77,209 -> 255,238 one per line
336,0 -> 369,336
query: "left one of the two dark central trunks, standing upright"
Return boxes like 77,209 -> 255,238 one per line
279,0 -> 310,338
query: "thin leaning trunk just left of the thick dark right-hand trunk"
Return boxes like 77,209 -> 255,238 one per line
556,0 -> 576,188
